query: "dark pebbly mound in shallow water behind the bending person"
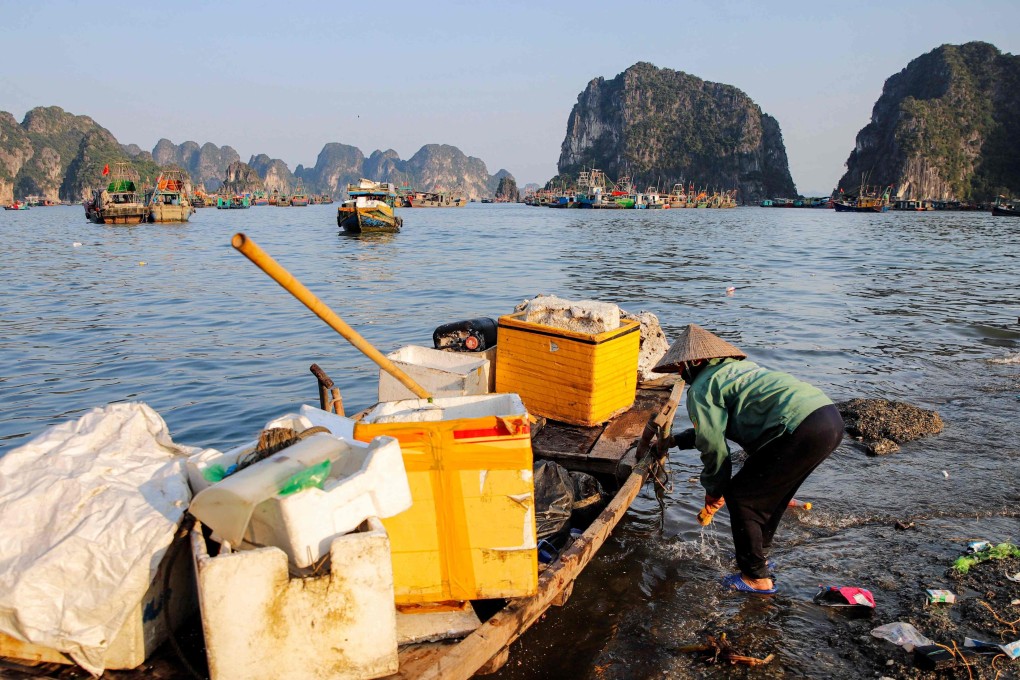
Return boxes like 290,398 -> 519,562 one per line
836,399 -> 942,456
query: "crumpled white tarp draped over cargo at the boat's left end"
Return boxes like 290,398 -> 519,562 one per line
0,403 -> 198,675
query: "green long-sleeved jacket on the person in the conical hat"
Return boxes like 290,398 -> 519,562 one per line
687,359 -> 832,498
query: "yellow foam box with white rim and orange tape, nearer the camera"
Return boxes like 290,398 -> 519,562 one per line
354,395 -> 538,605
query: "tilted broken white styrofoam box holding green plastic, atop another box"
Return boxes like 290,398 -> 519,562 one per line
190,432 -> 411,568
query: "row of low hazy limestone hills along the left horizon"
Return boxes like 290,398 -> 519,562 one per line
0,106 -> 513,203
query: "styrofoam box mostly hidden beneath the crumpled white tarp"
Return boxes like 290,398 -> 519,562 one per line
0,536 -> 198,671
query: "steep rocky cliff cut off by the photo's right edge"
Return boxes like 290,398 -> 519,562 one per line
839,42 -> 1020,201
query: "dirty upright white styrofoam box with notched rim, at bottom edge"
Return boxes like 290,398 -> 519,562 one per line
191,518 -> 398,680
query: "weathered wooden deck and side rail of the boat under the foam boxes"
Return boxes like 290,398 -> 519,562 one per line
0,380 -> 683,680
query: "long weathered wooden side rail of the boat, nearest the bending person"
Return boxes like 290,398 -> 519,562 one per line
390,384 -> 682,680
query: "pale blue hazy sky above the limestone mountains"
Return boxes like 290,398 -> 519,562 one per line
0,0 -> 1020,195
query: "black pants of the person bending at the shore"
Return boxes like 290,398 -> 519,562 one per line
723,404 -> 844,578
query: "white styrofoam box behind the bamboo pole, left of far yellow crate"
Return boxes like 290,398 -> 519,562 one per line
379,345 -> 492,402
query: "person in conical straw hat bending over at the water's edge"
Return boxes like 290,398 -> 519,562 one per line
652,324 -> 844,594
